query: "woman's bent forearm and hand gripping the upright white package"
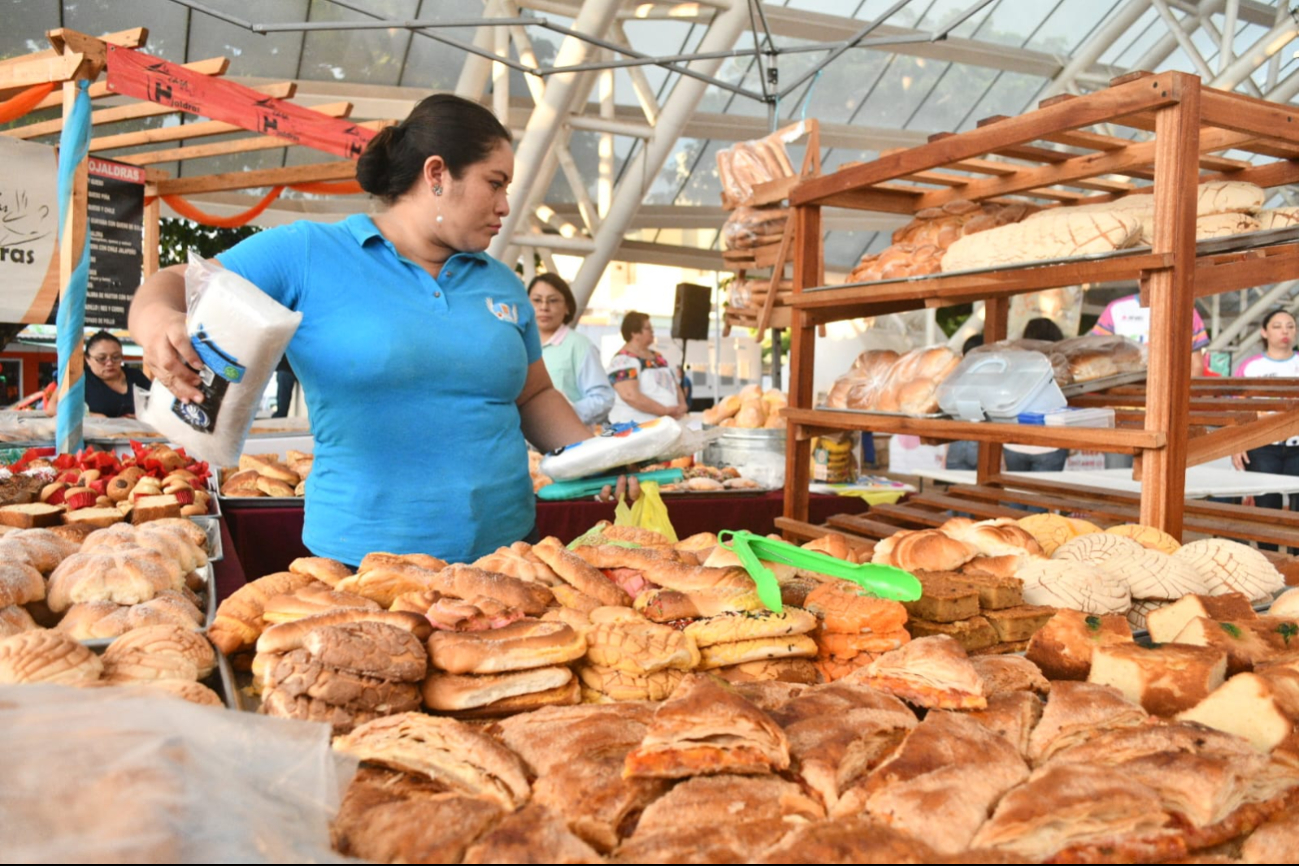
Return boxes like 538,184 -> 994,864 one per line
127,265 -> 203,402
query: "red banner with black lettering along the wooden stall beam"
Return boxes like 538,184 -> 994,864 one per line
108,45 -> 374,160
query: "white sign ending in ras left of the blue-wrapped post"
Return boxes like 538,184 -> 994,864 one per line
0,136 -> 58,323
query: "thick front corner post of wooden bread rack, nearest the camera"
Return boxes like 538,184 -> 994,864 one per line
1141,73 -> 1200,539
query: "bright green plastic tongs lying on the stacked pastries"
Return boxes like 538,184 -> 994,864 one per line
717,530 -> 921,613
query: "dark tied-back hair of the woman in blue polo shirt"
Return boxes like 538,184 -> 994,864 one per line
356,93 -> 513,204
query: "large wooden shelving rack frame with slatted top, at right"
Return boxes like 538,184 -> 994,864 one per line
781,73 -> 1299,538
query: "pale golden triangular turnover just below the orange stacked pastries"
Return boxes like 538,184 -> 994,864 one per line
848,635 -> 987,709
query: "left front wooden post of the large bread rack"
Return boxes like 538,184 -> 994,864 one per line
785,205 -> 825,529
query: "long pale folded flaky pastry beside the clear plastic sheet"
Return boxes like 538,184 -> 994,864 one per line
334,713 -> 531,811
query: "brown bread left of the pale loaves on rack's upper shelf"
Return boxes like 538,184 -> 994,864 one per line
847,199 -> 1037,283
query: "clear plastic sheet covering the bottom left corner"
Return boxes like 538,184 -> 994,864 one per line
0,686 -> 356,863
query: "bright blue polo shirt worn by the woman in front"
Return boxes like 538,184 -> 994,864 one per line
218,214 -> 542,565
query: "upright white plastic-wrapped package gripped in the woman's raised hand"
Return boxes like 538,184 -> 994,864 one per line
139,252 -> 303,466
